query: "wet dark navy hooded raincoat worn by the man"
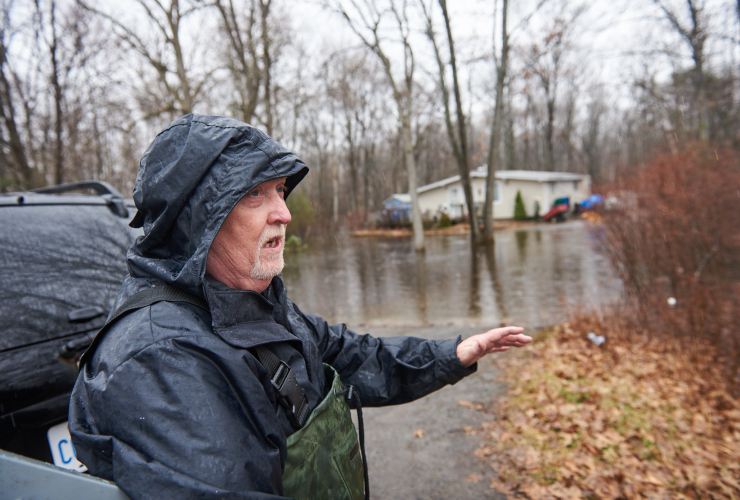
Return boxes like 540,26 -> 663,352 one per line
69,115 -> 475,499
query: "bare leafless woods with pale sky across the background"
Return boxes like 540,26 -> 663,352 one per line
0,0 -> 740,230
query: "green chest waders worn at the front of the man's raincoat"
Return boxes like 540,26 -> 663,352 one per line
283,364 -> 363,500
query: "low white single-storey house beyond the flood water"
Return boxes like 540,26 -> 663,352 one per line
416,166 -> 591,219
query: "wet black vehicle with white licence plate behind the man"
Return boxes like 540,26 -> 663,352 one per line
0,181 -> 140,470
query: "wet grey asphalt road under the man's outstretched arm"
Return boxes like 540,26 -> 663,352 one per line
353,326 -> 506,500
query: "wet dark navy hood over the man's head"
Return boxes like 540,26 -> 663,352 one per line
127,114 -> 308,297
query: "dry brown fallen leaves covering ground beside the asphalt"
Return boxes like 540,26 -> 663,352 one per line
476,317 -> 740,500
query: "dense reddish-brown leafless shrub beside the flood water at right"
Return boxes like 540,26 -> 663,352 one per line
603,145 -> 740,386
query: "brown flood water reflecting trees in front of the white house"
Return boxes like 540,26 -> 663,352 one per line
283,221 -> 621,328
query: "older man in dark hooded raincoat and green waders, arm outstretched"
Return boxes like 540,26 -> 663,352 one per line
69,115 -> 531,499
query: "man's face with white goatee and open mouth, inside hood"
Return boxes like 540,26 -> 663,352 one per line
206,177 -> 290,292
